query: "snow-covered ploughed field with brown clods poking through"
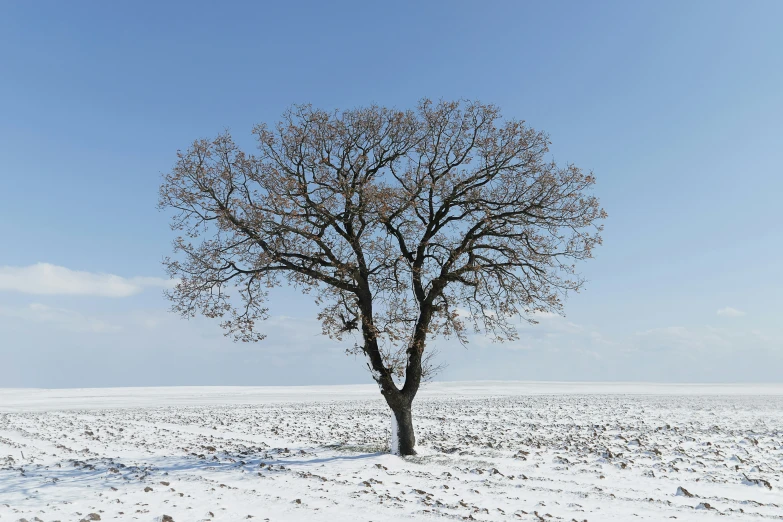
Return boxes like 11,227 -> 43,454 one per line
0,382 -> 783,522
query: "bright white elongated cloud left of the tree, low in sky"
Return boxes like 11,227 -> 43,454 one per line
0,263 -> 172,297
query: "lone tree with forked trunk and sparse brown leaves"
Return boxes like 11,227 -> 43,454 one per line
160,100 -> 606,455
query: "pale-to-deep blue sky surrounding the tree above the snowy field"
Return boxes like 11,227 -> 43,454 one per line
0,0 -> 783,387
